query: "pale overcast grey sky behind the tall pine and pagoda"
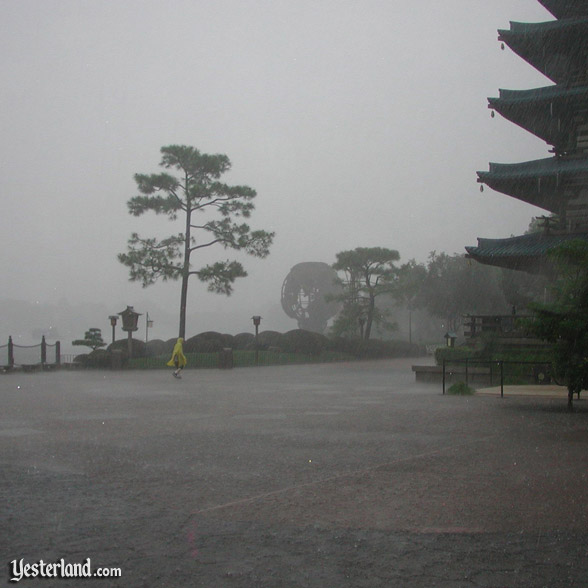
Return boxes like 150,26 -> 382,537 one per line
0,0 -> 552,338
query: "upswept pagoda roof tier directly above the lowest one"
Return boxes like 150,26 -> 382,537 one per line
477,157 -> 588,214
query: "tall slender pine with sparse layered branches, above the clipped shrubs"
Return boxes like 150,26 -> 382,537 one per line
118,145 -> 274,337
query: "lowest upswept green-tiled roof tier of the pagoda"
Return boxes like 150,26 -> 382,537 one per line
466,233 -> 588,273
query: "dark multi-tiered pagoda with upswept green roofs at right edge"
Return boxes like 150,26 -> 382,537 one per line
466,0 -> 588,273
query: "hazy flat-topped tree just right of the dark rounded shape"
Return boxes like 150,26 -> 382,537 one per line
333,247 -> 400,341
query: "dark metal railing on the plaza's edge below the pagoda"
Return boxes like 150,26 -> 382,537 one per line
443,359 -> 558,397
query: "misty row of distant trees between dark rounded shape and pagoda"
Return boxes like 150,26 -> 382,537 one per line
332,247 -> 547,340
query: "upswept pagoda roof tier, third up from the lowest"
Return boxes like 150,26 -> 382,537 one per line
488,85 -> 588,151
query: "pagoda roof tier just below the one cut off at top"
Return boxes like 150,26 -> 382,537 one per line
498,17 -> 588,84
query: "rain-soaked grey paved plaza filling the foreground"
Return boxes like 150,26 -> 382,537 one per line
0,360 -> 588,588
